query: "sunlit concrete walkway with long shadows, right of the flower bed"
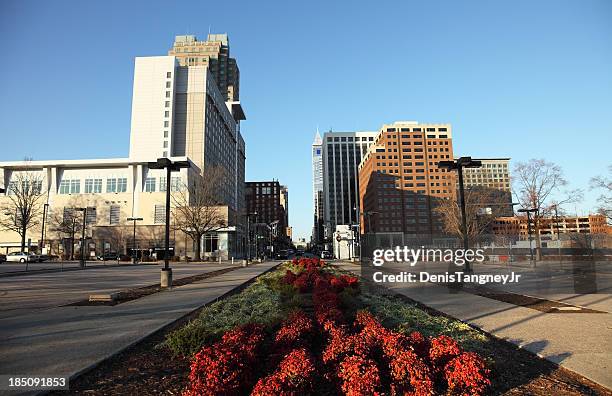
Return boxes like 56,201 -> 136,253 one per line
335,262 -> 612,389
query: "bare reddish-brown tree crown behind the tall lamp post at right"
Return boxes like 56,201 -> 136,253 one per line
434,187 -> 510,243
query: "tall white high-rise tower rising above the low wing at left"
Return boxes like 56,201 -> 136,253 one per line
130,36 -> 245,213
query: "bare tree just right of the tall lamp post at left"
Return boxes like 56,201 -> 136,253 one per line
172,167 -> 226,260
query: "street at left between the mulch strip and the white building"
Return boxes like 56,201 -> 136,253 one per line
0,262 -> 238,319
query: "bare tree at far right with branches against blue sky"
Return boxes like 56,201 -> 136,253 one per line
514,159 -> 582,260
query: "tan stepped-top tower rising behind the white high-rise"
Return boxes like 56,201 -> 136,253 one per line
168,34 -> 240,101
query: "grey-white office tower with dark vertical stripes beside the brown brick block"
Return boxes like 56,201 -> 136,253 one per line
322,131 -> 377,237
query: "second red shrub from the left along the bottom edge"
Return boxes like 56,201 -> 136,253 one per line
251,348 -> 315,396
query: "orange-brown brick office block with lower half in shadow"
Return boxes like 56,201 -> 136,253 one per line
359,121 -> 455,235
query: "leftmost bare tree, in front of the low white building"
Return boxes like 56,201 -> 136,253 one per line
0,171 -> 46,252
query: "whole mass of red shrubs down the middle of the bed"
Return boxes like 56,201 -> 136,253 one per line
185,259 -> 490,396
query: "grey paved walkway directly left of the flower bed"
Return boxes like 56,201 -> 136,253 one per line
0,262 -> 277,394
